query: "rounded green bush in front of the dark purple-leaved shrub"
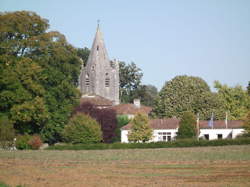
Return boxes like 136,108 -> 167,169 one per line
63,114 -> 102,144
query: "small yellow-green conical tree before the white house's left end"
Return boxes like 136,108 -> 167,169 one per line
128,114 -> 153,142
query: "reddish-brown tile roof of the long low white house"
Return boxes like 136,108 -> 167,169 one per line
122,118 -> 243,130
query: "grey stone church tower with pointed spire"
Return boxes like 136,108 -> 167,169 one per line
79,24 -> 119,105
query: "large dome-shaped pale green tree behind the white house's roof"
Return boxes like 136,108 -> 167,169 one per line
152,75 -> 225,120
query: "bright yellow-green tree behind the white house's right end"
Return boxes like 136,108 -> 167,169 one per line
214,81 -> 250,120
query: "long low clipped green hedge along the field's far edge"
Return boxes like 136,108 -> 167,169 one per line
46,138 -> 250,150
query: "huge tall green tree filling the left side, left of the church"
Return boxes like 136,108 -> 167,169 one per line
0,11 -> 81,143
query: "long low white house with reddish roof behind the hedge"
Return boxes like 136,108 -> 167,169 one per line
121,118 -> 244,143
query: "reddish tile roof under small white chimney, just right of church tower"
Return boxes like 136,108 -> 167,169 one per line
112,104 -> 152,115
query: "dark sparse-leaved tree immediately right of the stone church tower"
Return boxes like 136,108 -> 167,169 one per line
119,62 -> 143,103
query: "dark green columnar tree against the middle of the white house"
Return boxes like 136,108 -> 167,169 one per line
177,112 -> 196,138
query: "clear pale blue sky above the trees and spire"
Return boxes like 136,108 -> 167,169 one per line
0,0 -> 250,89
